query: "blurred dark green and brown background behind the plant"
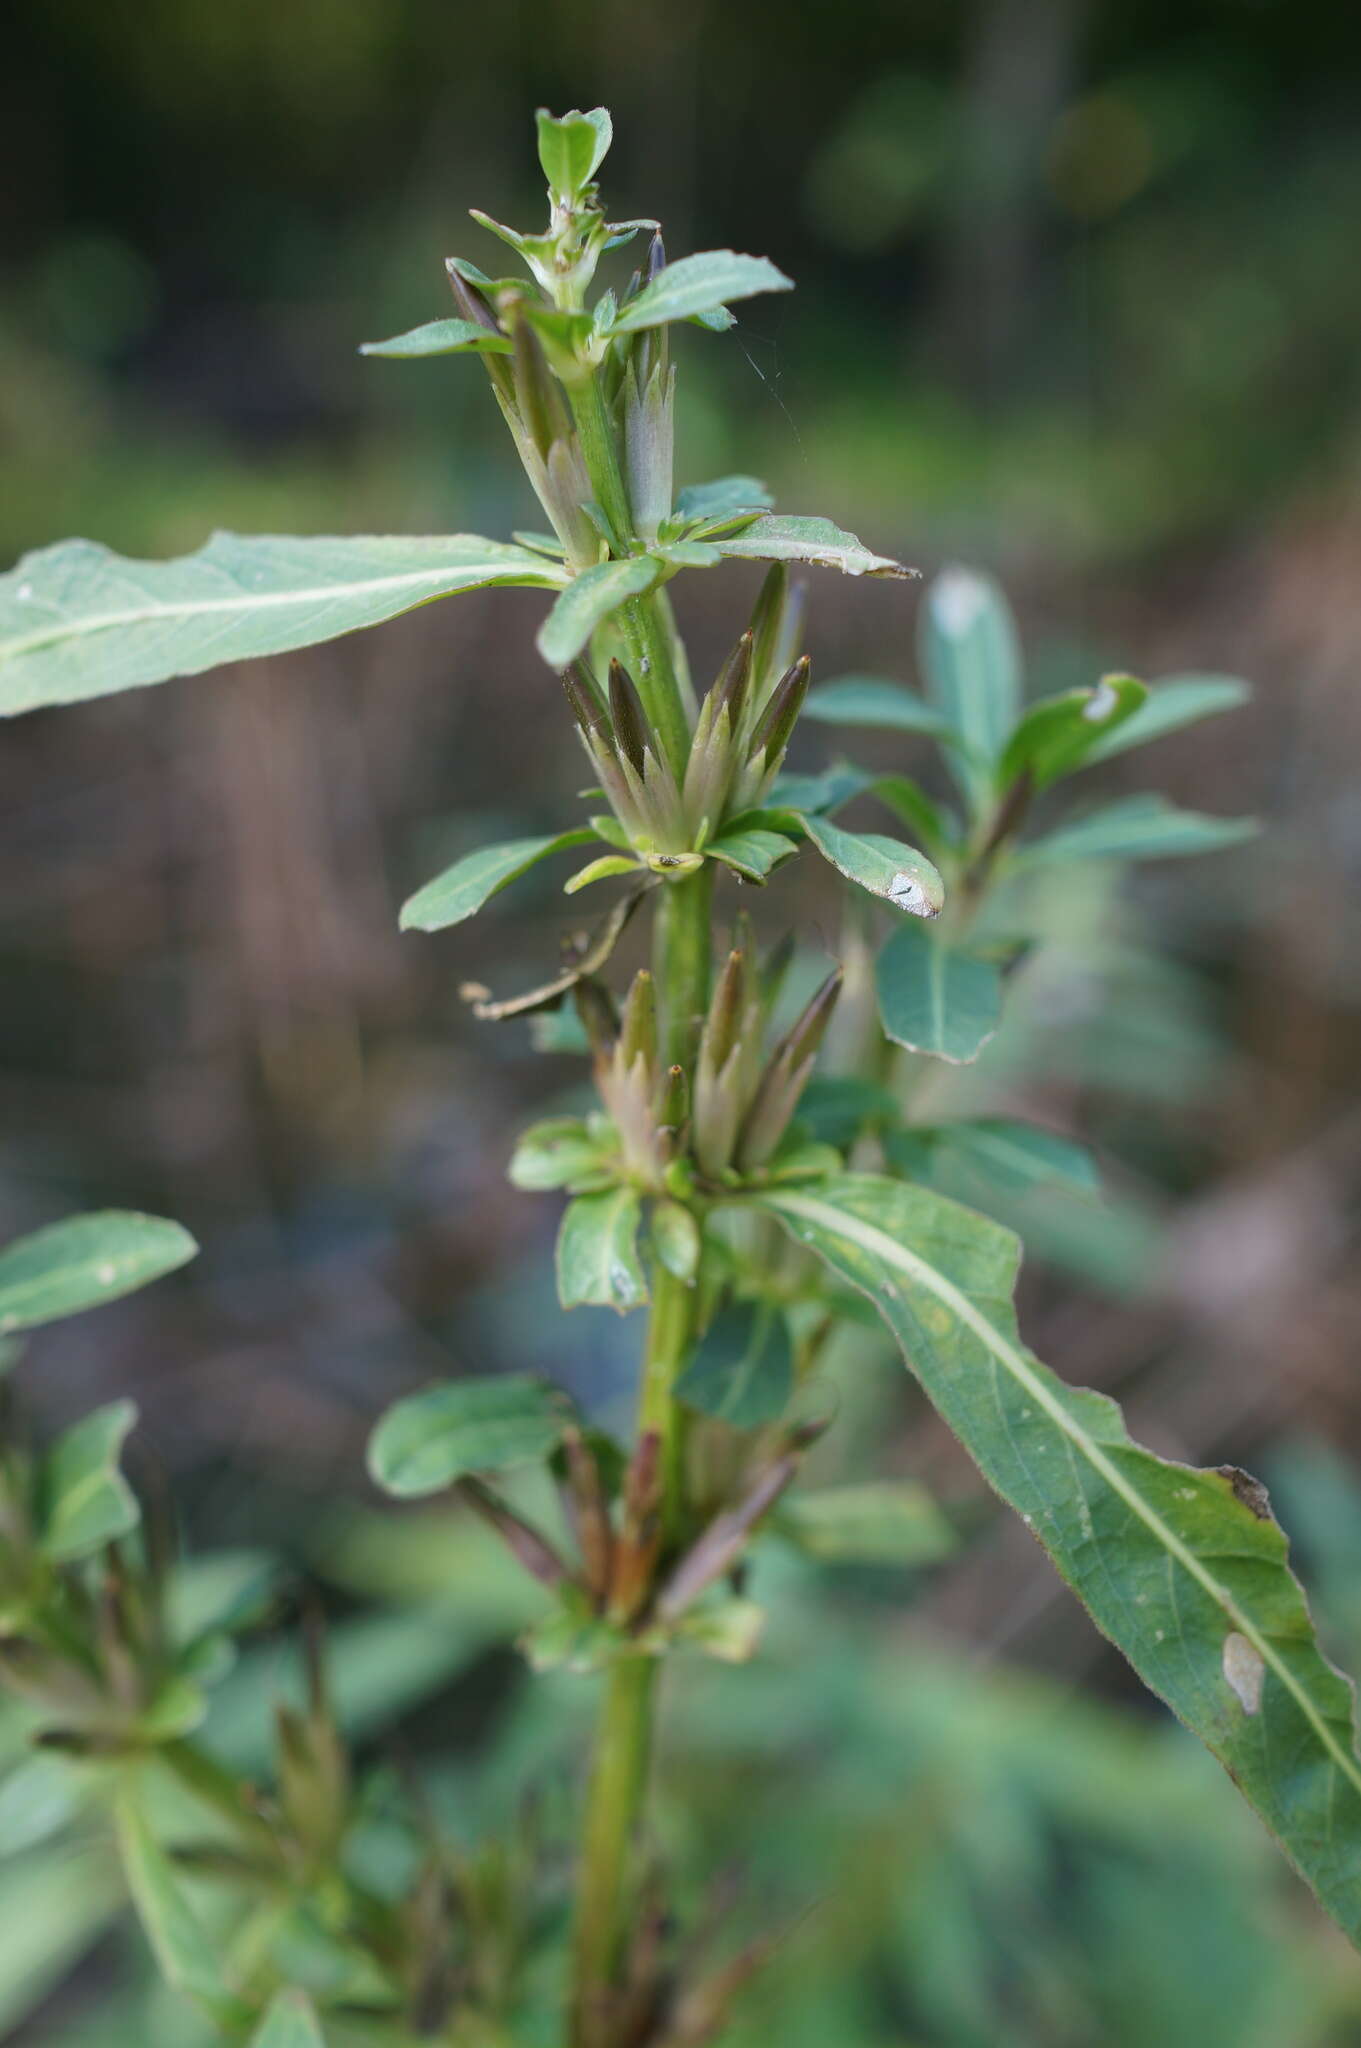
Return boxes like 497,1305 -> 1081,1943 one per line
0,0 -> 1361,2048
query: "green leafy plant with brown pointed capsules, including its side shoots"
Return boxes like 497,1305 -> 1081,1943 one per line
0,109 -> 1361,2048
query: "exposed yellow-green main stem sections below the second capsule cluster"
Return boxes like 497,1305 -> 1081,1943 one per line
571,864 -> 712,2048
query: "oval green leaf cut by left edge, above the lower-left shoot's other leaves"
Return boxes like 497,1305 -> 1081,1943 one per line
0,1208 -> 199,1331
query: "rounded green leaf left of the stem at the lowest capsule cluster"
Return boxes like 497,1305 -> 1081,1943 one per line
368,1372 -> 567,1499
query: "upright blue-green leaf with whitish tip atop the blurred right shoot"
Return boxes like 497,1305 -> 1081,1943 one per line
919,569 -> 1021,809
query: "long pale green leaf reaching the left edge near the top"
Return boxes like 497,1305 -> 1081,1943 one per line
0,532 -> 565,715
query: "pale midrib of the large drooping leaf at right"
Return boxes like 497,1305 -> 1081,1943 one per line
765,1194 -> 1361,1792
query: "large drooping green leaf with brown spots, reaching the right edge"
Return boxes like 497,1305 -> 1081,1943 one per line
759,1174 -> 1361,1944
